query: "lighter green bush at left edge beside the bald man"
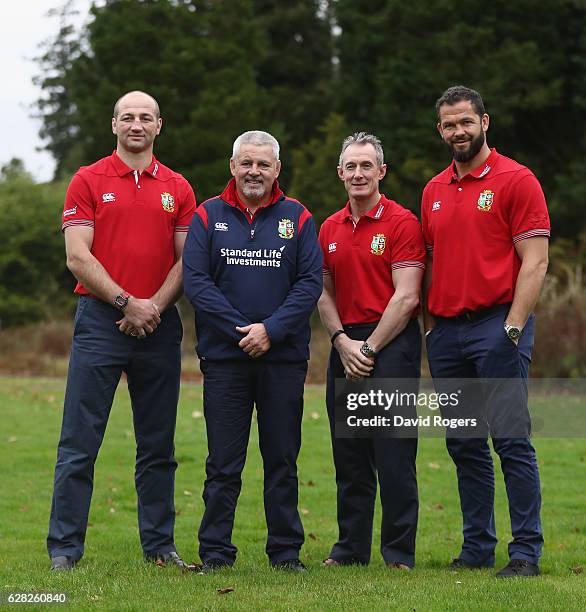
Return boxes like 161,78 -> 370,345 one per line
0,167 -> 73,327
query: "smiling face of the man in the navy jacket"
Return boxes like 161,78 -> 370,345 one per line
230,144 -> 281,206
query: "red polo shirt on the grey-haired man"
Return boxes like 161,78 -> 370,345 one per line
319,195 -> 425,325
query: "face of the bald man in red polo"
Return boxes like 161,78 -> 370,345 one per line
112,92 -> 162,154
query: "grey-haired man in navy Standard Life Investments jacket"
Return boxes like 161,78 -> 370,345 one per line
183,131 -> 322,573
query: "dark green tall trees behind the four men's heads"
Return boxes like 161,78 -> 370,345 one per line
13,0 -> 586,325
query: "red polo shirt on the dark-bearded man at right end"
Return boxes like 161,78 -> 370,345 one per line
421,149 -> 550,317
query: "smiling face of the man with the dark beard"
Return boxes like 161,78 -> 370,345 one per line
437,100 -> 489,163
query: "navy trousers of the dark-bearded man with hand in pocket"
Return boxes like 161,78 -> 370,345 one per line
426,304 -> 543,567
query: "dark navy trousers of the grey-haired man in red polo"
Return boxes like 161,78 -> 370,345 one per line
326,320 -> 421,567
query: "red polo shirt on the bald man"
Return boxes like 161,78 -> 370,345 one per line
62,152 -> 195,298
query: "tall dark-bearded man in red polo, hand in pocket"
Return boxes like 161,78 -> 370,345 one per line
421,86 -> 550,578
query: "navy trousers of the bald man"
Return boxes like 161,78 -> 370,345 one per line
47,296 -> 183,560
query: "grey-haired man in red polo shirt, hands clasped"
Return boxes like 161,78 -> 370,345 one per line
318,132 -> 425,569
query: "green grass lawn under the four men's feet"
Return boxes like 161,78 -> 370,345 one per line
0,378 -> 586,610
